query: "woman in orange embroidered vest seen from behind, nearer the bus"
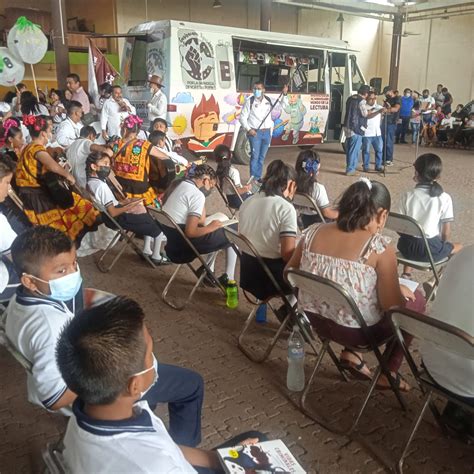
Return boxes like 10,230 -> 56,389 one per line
112,115 -> 168,206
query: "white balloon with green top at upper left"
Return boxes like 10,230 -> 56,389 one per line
7,16 -> 48,64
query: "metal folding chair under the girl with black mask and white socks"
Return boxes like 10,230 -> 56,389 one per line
74,186 -> 156,273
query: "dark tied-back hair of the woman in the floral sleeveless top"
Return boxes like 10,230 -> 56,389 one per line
337,178 -> 391,232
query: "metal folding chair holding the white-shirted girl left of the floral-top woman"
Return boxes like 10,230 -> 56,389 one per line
224,227 -> 317,363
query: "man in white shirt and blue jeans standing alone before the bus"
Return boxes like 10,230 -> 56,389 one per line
240,81 -> 288,180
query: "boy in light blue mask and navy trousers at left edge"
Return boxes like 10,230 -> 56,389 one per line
6,226 -> 203,446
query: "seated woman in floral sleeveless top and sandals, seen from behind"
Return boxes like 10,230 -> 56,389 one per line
287,178 -> 425,391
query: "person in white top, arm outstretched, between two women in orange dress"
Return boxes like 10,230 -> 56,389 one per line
66,125 -> 113,188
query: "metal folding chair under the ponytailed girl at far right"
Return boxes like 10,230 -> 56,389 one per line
385,212 -> 450,302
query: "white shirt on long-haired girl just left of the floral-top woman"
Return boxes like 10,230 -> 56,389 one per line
239,192 -> 297,258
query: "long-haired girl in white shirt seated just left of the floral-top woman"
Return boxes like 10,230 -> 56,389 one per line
239,160 -> 297,301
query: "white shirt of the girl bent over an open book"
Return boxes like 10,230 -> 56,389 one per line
163,179 -> 206,225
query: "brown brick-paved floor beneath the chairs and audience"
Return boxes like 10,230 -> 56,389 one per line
0,145 -> 474,474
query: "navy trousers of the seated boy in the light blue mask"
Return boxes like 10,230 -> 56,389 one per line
142,362 -> 204,447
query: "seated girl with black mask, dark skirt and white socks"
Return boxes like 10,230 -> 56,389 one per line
86,152 -> 170,265
